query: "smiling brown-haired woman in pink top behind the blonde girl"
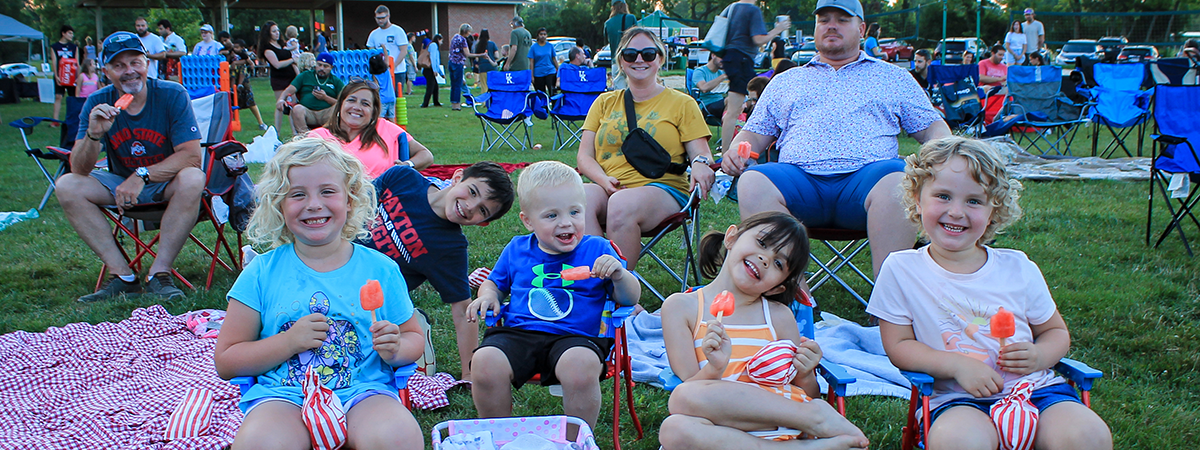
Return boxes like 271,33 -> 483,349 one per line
308,79 -> 433,180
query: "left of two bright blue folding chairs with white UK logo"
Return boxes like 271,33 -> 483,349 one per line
467,71 -> 548,151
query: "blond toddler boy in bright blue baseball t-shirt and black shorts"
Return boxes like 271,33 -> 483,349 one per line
467,161 -> 641,438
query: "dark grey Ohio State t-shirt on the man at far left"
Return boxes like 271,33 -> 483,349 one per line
76,78 -> 200,176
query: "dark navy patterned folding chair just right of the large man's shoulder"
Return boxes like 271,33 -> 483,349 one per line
929,64 -> 986,137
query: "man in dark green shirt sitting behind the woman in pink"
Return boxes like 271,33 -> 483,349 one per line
275,52 -> 345,136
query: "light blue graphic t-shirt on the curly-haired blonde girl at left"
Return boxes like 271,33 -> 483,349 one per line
228,244 -> 413,410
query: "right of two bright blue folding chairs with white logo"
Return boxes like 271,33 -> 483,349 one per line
550,66 -> 608,151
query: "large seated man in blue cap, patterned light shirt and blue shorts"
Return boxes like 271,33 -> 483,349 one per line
721,0 -> 950,283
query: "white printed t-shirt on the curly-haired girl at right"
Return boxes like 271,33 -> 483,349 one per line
866,246 -> 1063,409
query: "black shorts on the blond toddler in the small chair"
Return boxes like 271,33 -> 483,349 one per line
475,326 -> 613,388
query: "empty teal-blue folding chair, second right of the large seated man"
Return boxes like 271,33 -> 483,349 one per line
1001,66 -> 1087,155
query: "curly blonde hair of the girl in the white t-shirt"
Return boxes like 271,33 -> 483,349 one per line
902,137 -> 1021,245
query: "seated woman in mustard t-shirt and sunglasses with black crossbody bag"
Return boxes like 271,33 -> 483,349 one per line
576,28 -> 715,274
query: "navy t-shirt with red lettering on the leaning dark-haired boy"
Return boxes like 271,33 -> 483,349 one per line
358,166 -> 470,304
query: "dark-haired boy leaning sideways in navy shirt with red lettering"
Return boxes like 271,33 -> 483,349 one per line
359,161 -> 514,379
